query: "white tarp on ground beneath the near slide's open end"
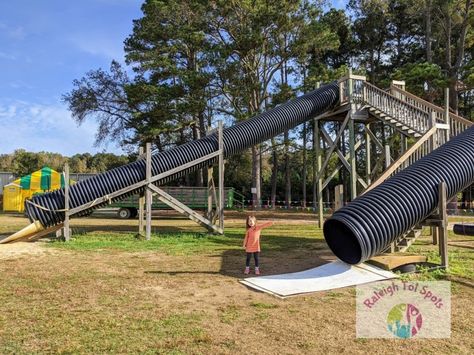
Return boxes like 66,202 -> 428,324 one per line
240,260 -> 398,297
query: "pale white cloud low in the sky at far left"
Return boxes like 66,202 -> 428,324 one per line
0,100 -> 121,156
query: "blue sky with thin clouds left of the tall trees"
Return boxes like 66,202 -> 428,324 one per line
0,0 -> 346,156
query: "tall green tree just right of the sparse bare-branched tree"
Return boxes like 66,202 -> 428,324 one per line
125,0 -> 212,185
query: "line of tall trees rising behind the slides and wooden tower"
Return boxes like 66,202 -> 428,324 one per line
63,0 -> 474,207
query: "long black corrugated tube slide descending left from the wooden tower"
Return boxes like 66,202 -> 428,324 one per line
25,83 -> 339,228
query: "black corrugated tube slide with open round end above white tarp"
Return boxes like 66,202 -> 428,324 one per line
324,127 -> 474,264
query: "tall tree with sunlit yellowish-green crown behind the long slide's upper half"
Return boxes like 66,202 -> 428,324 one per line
209,0 -> 332,207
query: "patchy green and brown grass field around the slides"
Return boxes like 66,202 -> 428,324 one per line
0,213 -> 474,354
